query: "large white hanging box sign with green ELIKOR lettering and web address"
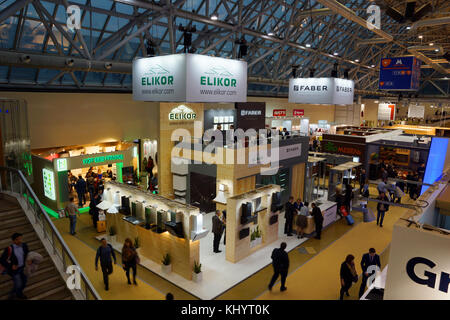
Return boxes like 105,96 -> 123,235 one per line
133,54 -> 247,102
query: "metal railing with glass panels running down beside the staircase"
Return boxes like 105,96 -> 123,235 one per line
0,167 -> 101,300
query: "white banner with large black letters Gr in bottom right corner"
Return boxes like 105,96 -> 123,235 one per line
384,226 -> 450,300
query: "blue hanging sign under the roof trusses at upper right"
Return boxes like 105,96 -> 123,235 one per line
378,56 -> 421,90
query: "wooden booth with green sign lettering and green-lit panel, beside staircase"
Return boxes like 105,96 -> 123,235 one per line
32,142 -> 138,216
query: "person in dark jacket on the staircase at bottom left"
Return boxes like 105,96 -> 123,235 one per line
0,233 -> 32,299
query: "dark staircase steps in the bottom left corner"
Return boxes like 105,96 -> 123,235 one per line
0,195 -> 74,300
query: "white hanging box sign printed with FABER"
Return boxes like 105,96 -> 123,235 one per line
289,78 -> 355,104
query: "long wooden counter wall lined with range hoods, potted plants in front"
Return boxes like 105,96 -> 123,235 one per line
101,182 -> 208,279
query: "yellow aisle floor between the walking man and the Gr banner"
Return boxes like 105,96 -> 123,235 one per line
258,199 -> 411,300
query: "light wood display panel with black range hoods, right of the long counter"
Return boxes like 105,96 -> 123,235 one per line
226,185 -> 281,263
